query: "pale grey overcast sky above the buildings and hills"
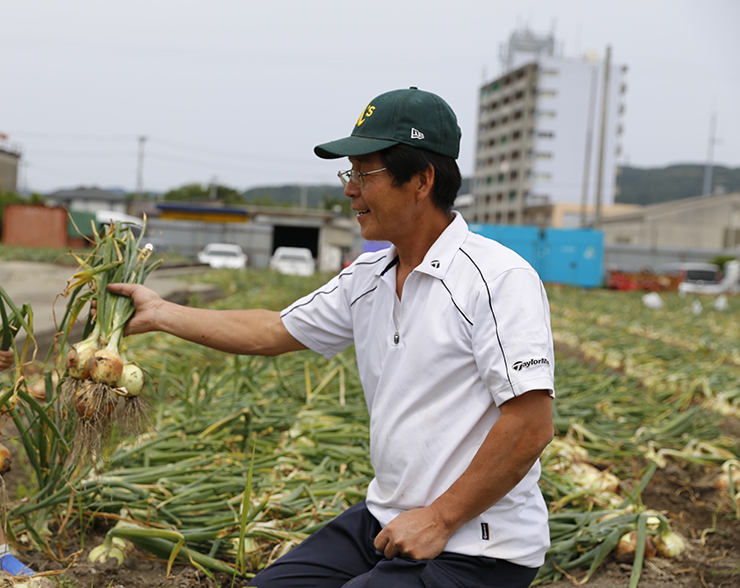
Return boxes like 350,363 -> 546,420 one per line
0,0 -> 740,193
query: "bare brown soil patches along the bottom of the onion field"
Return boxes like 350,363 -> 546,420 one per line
4,448 -> 740,588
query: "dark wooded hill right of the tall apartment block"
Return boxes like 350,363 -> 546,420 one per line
615,164 -> 740,204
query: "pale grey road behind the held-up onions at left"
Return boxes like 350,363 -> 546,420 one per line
0,261 -> 220,359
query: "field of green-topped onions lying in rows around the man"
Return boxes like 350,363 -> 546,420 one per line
0,270 -> 740,587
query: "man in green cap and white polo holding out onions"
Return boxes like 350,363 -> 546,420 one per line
110,88 -> 554,588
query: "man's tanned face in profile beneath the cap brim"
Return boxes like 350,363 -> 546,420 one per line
344,153 -> 415,246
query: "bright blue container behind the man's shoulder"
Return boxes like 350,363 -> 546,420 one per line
469,223 -> 604,288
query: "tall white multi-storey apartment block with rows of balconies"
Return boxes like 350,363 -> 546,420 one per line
467,30 -> 627,226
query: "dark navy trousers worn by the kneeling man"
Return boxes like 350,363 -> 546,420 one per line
249,502 -> 538,588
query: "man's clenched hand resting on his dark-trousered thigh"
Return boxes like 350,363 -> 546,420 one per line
375,506 -> 452,560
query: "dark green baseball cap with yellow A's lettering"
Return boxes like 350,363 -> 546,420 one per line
313,87 -> 462,159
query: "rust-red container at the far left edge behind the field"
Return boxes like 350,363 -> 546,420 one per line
3,204 -> 67,247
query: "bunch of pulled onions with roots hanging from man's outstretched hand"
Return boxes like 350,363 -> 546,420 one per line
62,218 -> 161,461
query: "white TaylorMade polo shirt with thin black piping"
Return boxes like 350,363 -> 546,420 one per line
281,214 -> 554,567
